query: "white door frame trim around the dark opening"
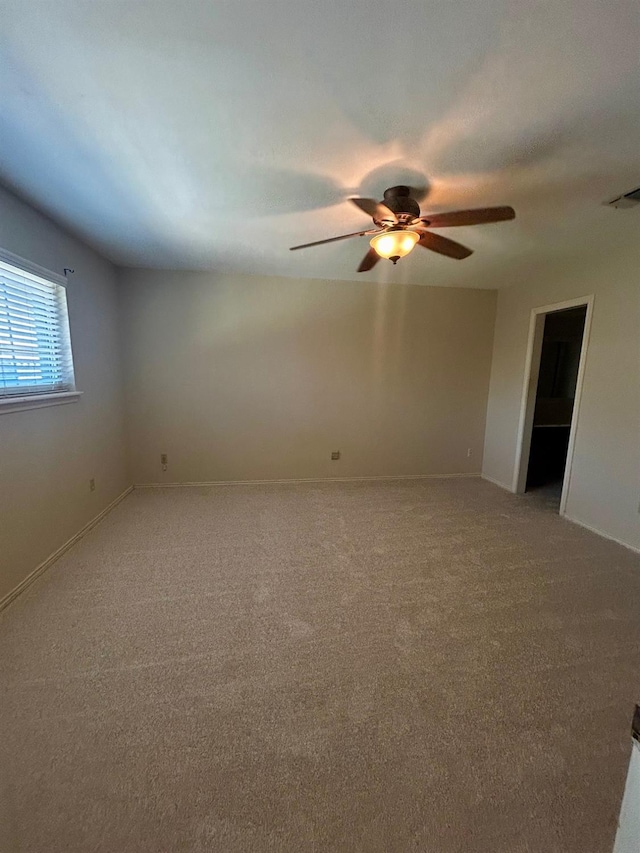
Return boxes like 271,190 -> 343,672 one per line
512,294 -> 594,515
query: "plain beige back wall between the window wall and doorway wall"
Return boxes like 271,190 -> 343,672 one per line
121,270 -> 496,483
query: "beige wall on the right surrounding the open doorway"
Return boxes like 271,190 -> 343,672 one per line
483,230 -> 640,548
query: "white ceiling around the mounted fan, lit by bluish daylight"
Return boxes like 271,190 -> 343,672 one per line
0,0 -> 640,287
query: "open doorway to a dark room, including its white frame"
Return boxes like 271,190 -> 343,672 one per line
514,297 -> 592,514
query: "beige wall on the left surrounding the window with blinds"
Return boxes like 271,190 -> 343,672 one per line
0,190 -> 129,599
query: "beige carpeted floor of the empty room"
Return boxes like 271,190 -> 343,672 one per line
0,480 -> 640,853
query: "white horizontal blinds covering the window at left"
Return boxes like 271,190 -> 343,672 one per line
0,258 -> 75,397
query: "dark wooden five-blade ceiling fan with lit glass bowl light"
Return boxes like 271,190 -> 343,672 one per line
291,186 -> 516,272
